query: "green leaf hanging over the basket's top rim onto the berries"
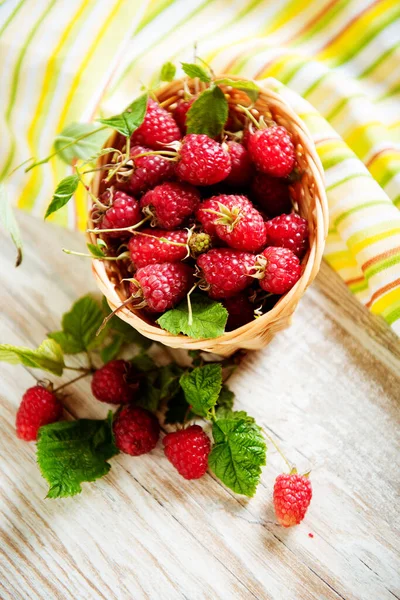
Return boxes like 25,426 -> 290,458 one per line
186,86 -> 228,138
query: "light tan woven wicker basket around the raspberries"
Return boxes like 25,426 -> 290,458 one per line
91,76 -> 328,356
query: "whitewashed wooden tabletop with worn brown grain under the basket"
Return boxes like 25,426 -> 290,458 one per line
0,214 -> 400,600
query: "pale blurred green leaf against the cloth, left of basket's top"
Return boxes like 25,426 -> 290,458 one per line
54,123 -> 110,165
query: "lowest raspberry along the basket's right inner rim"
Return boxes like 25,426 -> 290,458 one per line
256,246 -> 301,294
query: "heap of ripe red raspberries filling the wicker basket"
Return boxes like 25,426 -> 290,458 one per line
92,98 -> 309,331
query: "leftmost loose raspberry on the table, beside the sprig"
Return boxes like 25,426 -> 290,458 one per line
16,385 -> 63,442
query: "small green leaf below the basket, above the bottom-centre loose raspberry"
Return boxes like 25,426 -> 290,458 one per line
180,363 -> 222,417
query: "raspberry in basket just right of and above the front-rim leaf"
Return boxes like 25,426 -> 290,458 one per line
197,248 -> 256,299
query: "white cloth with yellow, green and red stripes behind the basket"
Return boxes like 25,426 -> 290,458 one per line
0,0 -> 400,333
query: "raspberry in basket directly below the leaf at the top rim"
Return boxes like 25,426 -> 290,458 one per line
175,133 -> 231,185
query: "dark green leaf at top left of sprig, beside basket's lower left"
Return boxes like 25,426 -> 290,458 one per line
48,295 -> 106,354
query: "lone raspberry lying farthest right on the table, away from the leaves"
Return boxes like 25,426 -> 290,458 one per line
274,473 -> 312,527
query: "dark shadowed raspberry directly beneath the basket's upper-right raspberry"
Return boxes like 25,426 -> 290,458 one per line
251,173 -> 292,218
